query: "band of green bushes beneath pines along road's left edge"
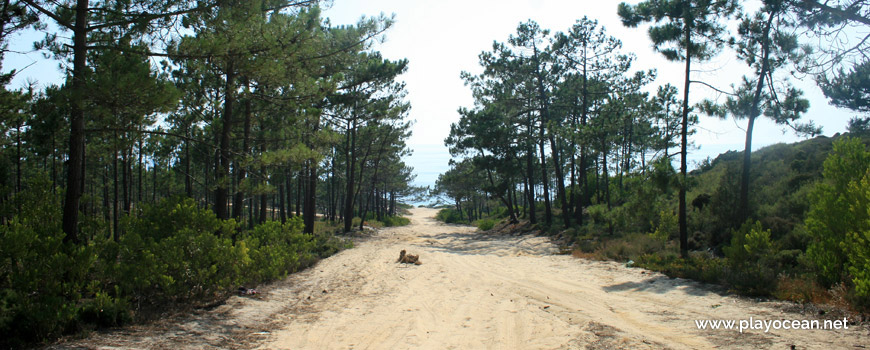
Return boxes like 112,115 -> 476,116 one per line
0,185 -> 350,347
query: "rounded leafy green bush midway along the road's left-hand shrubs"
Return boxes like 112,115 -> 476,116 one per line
114,198 -> 250,303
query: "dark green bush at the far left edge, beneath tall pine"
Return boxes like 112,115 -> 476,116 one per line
0,176 -> 97,347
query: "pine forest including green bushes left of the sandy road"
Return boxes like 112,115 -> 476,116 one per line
0,0 -> 416,348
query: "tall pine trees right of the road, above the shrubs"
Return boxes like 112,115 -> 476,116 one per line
437,0 -> 870,257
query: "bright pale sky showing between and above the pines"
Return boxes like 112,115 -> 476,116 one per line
3,0 -> 856,191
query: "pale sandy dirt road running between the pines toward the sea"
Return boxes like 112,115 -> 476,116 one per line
59,208 -> 870,349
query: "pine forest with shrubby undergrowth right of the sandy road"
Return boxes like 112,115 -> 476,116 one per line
434,0 -> 870,313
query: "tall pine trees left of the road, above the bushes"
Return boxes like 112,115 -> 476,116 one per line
0,0 -> 412,242
